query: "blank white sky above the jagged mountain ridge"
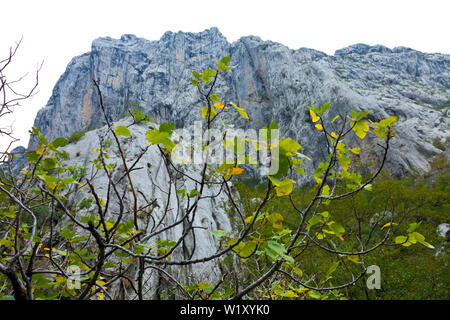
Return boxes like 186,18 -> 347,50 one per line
0,0 -> 450,150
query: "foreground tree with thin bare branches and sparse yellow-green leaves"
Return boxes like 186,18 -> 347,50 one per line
0,52 -> 431,299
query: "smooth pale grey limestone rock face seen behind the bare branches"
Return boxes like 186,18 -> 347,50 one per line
58,117 -> 232,299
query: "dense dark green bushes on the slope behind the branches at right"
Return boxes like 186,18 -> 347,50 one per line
236,157 -> 450,300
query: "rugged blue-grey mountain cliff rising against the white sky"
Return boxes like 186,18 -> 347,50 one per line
28,28 -> 450,180
